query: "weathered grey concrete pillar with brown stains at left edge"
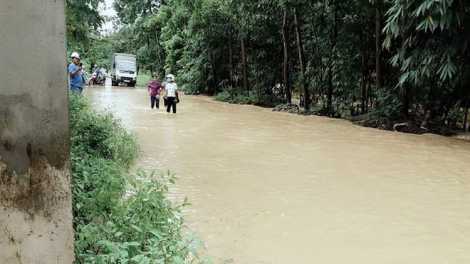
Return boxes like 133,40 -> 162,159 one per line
0,0 -> 73,264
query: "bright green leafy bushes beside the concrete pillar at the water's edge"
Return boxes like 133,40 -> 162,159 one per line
70,94 -> 203,264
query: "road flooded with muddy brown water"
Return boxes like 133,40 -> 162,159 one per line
85,87 -> 470,264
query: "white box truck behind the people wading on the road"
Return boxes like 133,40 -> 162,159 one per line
111,53 -> 137,87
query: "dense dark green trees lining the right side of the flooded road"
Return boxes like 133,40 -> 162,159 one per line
97,0 -> 470,131
